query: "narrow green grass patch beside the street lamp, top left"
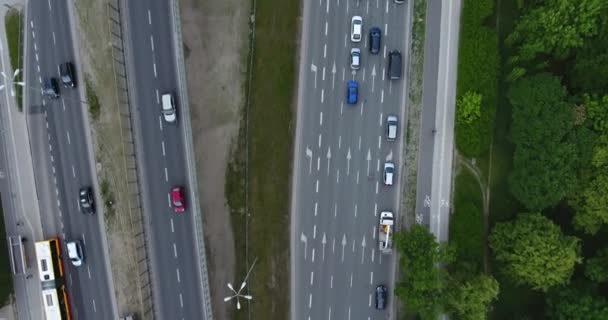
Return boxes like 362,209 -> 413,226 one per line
4,9 -> 23,111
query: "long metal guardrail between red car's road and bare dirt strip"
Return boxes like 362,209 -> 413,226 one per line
169,0 -> 213,320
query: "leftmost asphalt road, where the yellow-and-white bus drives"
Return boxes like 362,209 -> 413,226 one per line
24,0 -> 116,319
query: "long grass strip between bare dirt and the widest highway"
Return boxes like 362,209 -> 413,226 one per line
226,0 -> 299,319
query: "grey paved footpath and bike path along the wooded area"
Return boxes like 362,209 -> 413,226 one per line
416,0 -> 461,241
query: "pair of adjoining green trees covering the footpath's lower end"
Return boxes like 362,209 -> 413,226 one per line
395,225 -> 498,320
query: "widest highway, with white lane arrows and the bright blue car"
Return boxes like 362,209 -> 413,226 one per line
291,0 -> 411,319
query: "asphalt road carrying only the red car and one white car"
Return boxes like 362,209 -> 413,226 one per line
126,0 -> 204,319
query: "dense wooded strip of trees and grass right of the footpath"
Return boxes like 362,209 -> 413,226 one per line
444,0 -> 608,319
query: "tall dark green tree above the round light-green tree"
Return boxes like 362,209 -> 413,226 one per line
508,74 -> 577,211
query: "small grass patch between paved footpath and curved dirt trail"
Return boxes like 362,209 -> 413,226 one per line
450,167 -> 485,270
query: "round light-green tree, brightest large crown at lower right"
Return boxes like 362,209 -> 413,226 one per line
490,213 -> 581,291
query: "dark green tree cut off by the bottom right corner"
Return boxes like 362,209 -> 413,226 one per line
547,287 -> 608,320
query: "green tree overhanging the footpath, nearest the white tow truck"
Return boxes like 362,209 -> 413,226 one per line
394,224 -> 453,319
